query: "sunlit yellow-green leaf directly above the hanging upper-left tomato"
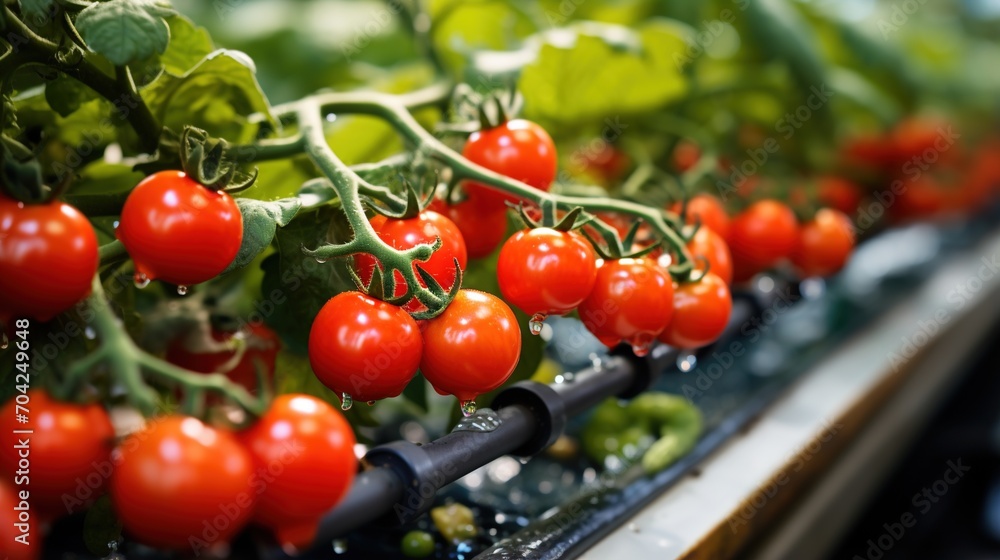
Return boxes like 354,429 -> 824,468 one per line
142,49 -> 278,143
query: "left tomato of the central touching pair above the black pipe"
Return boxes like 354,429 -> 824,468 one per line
309,292 -> 421,401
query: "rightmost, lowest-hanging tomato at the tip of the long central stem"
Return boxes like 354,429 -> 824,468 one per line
659,272 -> 733,348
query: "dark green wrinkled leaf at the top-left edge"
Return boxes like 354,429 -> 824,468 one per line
76,0 -> 173,66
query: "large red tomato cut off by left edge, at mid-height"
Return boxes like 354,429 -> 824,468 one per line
0,195 -> 98,321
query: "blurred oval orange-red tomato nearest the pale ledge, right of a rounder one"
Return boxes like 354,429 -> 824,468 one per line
792,208 -> 854,276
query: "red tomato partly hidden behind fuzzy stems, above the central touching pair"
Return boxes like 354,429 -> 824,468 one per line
354,210 -> 469,311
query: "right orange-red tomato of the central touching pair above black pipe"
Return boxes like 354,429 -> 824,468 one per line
420,290 -> 521,402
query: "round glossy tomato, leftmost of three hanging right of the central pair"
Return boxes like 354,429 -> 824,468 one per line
497,228 -> 597,315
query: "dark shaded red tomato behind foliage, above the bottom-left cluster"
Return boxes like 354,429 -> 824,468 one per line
166,324 -> 281,396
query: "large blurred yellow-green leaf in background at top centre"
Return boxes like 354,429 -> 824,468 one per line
519,21 -> 687,126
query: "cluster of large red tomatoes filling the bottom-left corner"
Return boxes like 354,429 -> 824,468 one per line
0,390 -> 357,558
